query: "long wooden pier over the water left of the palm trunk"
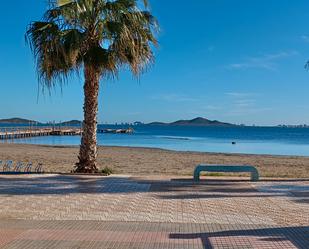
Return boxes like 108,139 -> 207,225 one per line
0,126 -> 82,140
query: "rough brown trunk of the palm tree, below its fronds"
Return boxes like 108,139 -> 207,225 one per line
75,65 -> 100,173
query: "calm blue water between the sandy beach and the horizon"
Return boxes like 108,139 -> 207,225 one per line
2,125 -> 309,156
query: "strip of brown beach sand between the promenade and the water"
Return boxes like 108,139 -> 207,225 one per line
0,144 -> 309,178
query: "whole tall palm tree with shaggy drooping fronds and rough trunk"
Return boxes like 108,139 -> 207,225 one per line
26,0 -> 157,173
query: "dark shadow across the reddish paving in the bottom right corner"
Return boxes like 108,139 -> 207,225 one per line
169,226 -> 309,249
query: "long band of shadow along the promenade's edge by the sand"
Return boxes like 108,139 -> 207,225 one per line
0,175 -> 308,204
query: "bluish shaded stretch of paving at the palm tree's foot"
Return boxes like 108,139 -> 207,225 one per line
0,175 -> 149,196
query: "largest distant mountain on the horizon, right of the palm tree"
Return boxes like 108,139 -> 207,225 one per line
148,117 -> 236,126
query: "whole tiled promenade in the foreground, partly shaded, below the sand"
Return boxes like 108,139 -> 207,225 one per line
0,175 -> 309,249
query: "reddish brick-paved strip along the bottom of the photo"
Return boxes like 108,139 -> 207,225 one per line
0,220 -> 309,249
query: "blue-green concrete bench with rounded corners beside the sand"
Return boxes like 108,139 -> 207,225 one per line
194,165 -> 259,182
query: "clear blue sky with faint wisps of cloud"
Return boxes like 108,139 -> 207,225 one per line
0,0 -> 309,125
